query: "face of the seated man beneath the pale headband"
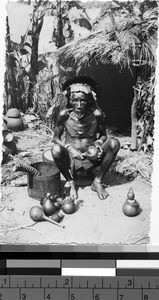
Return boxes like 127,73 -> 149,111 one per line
70,93 -> 88,116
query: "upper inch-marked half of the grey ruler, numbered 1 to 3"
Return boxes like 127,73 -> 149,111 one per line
0,275 -> 159,290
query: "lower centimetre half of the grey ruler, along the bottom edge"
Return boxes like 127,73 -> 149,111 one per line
0,288 -> 159,300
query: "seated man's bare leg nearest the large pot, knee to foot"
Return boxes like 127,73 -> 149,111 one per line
52,144 -> 77,199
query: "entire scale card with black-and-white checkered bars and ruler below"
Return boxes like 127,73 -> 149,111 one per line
0,259 -> 159,300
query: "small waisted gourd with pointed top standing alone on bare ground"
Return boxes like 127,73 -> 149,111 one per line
122,187 -> 141,217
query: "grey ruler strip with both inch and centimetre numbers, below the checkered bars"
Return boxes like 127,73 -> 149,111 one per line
0,275 -> 159,300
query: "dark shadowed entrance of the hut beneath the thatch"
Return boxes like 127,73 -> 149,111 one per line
80,63 -> 136,132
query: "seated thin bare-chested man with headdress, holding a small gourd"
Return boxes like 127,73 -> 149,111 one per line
52,76 -> 120,200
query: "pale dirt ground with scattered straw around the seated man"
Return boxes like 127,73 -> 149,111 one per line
0,126 -> 151,245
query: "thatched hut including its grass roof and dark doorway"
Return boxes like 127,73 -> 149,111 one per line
58,1 -> 158,137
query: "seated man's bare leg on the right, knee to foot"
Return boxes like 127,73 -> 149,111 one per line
91,138 -> 120,200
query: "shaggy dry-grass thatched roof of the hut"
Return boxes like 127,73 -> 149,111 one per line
58,3 -> 158,67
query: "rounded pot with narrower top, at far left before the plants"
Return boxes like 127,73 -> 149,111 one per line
6,108 -> 23,131
